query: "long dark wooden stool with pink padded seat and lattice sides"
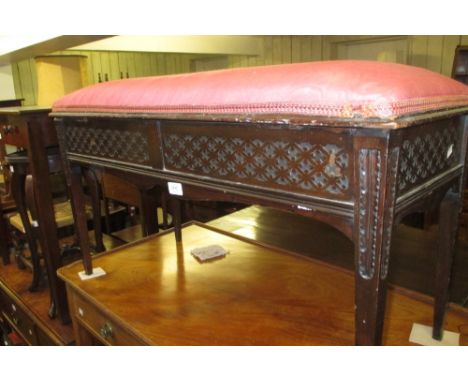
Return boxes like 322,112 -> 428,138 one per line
52,61 -> 468,345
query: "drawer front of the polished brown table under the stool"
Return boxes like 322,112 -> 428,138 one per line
72,293 -> 145,345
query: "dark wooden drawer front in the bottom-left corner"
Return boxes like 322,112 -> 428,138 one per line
0,291 -> 38,345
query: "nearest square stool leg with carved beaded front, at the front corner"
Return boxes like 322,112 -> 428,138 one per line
354,143 -> 399,345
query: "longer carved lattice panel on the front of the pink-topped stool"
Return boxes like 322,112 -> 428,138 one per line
164,133 -> 350,196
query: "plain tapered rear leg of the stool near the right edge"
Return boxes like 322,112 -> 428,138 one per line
432,191 -> 461,340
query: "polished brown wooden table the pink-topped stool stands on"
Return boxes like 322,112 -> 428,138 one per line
59,224 -> 468,345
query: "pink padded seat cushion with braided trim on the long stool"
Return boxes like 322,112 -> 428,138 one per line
53,60 -> 468,119
